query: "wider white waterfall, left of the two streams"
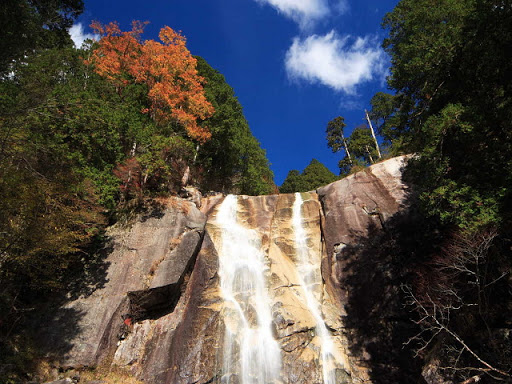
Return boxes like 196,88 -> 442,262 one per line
217,195 -> 281,384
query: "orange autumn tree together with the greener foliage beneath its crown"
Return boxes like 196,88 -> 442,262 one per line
87,21 -> 214,191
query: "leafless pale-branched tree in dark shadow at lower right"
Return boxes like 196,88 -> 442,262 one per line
402,230 -> 511,381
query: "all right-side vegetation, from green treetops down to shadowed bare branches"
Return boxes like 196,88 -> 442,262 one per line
362,0 -> 512,383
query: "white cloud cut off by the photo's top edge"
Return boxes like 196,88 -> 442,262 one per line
256,0 -> 338,28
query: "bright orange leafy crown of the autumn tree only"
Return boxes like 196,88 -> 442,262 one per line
88,21 -> 214,142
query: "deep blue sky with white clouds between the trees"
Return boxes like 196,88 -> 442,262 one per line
71,0 -> 398,185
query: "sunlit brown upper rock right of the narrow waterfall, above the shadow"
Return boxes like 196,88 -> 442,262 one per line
318,156 -> 407,308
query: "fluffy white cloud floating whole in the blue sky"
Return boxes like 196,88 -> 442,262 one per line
285,31 -> 386,94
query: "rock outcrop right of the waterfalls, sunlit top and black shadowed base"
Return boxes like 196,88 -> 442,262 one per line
318,157 -> 409,383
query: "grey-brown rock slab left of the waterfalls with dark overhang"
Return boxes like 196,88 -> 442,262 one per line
37,199 -> 206,367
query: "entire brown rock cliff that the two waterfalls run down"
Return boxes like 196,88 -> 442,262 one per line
38,158 -> 406,384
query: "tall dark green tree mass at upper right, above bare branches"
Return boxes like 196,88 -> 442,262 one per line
384,0 -> 512,230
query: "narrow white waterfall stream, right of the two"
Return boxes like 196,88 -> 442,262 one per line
292,193 -> 336,384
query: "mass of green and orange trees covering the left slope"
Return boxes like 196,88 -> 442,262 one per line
0,9 -> 274,382
